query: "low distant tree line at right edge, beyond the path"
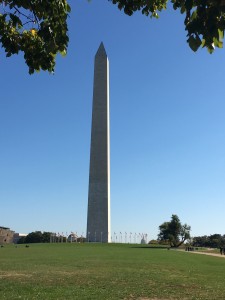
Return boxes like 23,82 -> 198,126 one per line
192,233 -> 225,248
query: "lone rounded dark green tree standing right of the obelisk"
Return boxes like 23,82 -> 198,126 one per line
158,215 -> 191,247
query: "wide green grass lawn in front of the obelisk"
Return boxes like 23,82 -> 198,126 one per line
0,243 -> 225,300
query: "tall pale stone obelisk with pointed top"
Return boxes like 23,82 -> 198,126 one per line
87,43 -> 111,243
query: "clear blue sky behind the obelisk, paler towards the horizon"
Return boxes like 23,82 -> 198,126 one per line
0,0 -> 225,239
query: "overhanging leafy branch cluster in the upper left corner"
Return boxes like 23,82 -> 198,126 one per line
0,0 -> 70,74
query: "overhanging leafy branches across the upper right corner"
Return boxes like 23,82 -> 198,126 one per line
110,0 -> 225,53
